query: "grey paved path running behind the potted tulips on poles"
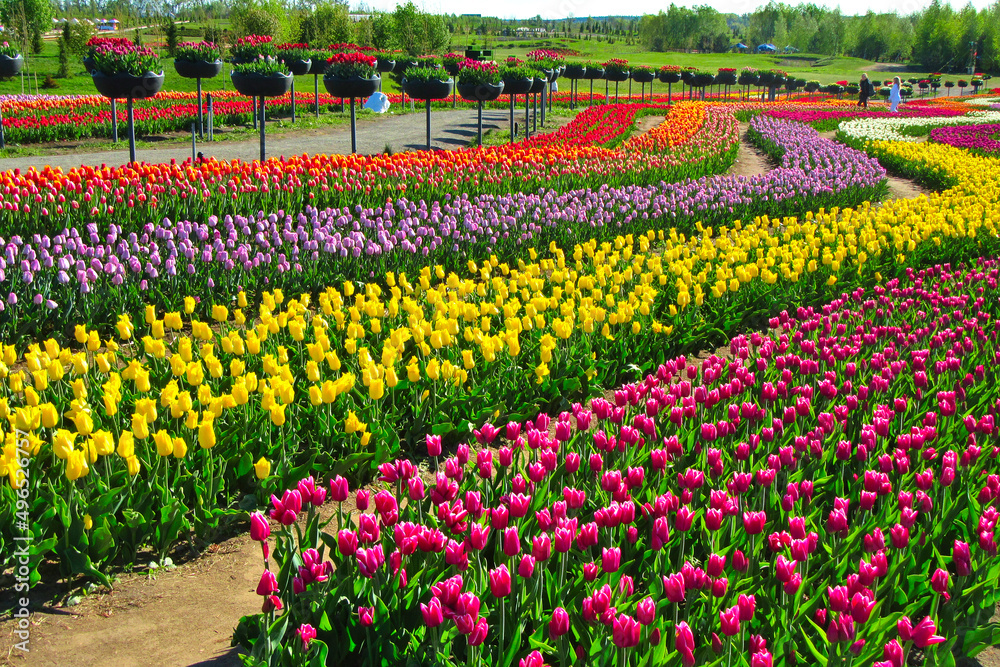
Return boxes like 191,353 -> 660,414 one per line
0,106 -> 551,171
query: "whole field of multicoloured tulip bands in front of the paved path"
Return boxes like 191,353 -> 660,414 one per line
0,93 -> 1000,667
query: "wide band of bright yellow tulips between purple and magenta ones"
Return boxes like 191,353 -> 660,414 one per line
0,120 -> 1000,577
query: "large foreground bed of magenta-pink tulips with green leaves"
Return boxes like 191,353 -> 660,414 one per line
235,261 -> 1000,667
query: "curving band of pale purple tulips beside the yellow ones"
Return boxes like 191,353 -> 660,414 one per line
0,110 -> 885,340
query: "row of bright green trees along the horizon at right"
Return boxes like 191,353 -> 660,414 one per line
639,0 -> 1000,71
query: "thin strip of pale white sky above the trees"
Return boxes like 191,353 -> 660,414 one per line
351,0 -> 995,19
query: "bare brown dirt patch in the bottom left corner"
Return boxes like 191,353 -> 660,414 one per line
0,535 -> 261,667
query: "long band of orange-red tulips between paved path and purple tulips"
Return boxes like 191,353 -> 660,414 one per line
0,106 -> 728,241
